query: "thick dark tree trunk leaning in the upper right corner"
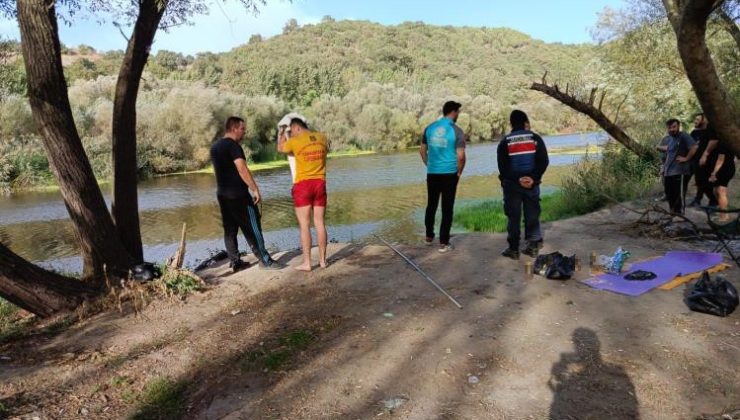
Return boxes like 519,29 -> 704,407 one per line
663,0 -> 740,156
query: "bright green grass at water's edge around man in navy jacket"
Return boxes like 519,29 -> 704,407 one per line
455,191 -> 582,232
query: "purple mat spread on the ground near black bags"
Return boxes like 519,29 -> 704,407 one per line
583,251 -> 722,296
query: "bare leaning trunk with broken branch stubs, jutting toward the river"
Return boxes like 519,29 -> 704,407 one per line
530,82 -> 655,158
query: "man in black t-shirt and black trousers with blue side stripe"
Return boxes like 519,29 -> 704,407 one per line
211,117 -> 283,272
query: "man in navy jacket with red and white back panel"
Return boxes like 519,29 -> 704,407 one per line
496,109 -> 550,260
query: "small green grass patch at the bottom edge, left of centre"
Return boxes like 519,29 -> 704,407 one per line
130,377 -> 187,420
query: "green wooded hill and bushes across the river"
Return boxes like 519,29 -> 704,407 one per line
0,18 -> 595,189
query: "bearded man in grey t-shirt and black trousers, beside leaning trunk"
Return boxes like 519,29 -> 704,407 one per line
656,118 -> 698,214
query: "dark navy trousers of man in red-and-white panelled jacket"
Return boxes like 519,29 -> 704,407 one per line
501,180 -> 542,250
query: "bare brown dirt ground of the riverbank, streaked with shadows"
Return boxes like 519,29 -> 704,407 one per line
0,208 -> 740,419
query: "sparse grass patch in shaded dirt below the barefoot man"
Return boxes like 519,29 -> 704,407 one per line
239,330 -> 316,371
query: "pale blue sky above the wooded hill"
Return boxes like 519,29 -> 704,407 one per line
0,0 -> 624,54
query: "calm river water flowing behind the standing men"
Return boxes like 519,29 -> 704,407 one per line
0,133 -> 607,272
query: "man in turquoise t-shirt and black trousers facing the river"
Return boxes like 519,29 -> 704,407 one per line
419,101 -> 466,252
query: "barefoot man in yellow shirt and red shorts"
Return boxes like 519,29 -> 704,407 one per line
278,118 -> 329,271
